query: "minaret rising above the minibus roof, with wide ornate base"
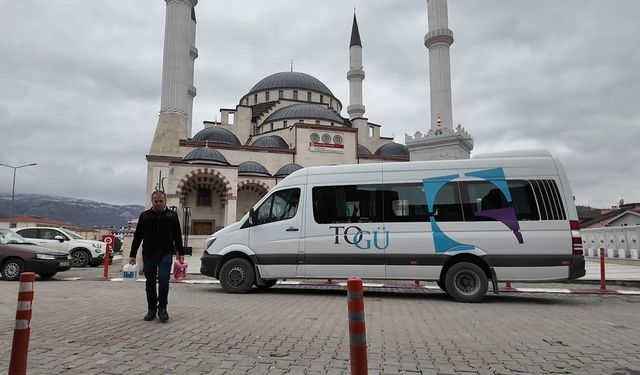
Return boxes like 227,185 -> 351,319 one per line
405,0 -> 473,160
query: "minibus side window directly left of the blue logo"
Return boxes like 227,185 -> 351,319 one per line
382,183 -> 429,222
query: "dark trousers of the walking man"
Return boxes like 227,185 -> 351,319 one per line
144,254 -> 173,310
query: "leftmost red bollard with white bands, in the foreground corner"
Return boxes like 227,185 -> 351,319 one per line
9,272 -> 36,375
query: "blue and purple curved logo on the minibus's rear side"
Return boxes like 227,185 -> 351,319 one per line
422,168 -> 524,253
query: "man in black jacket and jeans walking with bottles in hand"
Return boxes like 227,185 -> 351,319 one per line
129,191 -> 182,323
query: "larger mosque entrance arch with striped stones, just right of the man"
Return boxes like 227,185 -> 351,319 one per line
176,168 -> 230,236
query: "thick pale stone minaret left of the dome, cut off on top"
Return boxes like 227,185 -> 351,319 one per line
149,0 -> 198,156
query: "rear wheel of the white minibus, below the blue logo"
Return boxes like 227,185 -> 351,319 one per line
445,262 -> 489,303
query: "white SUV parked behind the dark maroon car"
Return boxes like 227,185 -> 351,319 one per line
14,227 -> 113,267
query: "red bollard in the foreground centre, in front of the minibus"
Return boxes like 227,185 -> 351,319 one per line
347,277 -> 368,375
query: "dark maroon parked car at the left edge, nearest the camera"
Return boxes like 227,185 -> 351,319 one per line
0,229 -> 72,280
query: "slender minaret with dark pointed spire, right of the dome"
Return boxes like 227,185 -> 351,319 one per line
347,13 -> 364,120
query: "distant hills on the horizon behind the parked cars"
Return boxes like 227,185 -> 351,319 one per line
0,193 -> 144,228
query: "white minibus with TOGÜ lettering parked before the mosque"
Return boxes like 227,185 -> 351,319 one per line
200,151 -> 585,302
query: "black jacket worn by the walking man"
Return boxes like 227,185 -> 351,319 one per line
129,208 -> 182,258
